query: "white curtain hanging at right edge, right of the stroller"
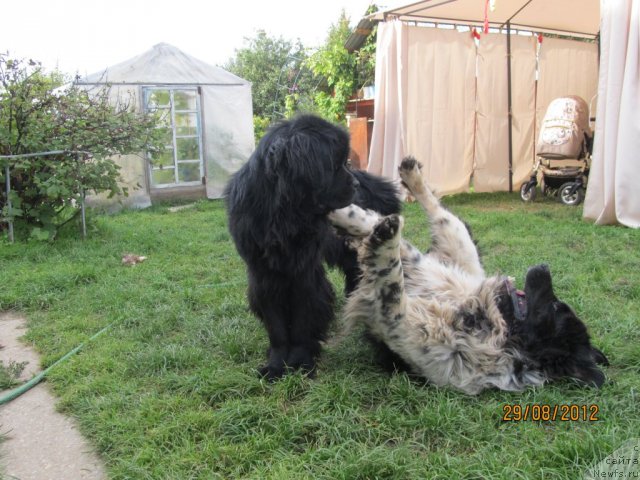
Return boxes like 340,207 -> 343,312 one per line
583,0 -> 640,228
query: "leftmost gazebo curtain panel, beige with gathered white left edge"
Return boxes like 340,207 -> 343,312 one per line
368,20 -> 475,194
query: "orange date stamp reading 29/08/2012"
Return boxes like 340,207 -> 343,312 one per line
501,403 -> 600,422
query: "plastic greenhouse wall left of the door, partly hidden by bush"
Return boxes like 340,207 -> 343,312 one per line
86,85 -> 151,211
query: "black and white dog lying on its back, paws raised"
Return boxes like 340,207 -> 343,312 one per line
330,157 -> 608,394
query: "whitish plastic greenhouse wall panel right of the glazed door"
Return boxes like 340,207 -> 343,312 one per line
201,85 -> 255,198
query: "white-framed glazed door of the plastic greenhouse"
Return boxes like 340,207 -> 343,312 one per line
144,87 -> 204,188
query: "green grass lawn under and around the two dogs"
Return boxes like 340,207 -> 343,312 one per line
0,194 -> 640,480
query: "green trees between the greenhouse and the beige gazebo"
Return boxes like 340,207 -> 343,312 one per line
224,5 -> 377,127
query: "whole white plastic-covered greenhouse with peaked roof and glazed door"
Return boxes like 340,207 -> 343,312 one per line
77,43 -> 254,207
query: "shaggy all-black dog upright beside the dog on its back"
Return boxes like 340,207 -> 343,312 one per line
225,115 -> 401,379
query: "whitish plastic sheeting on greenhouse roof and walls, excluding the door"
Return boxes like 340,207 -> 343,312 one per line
78,44 -> 254,209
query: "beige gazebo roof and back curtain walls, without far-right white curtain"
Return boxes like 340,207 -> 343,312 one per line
368,0 -> 599,193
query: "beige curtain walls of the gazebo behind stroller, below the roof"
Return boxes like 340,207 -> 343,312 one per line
369,20 -> 597,194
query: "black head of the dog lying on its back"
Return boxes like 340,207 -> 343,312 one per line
520,265 -> 609,387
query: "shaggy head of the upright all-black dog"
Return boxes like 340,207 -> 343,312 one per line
252,115 -> 358,214
